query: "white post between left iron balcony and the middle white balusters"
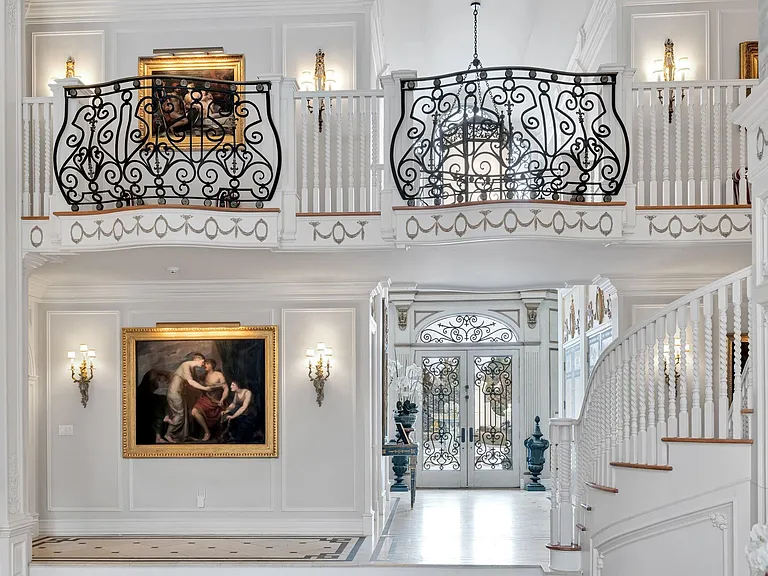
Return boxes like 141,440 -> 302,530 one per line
277,78 -> 301,244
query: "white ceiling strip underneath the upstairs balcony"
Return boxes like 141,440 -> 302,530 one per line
34,240 -> 751,290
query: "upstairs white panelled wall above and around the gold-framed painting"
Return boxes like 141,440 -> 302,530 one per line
26,13 -> 371,96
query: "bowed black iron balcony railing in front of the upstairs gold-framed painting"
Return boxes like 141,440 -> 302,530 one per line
54,75 -> 282,211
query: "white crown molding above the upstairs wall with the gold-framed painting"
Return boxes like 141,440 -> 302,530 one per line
26,0 -> 371,24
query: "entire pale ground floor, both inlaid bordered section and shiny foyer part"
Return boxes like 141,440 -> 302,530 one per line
32,489 -> 549,568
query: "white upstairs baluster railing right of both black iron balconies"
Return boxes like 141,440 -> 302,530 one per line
627,80 -> 757,206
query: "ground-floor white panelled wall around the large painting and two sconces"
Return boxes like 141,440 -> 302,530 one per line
37,289 -> 372,534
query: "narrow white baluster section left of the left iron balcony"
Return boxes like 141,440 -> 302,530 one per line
21,98 -> 55,217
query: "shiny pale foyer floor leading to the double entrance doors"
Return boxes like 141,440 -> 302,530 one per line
371,489 -> 550,566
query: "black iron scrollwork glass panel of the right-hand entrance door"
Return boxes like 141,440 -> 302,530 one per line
472,356 -> 513,470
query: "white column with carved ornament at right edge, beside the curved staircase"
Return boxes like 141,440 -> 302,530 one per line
733,77 -> 768,523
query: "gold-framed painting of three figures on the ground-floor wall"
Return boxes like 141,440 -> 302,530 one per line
123,326 -> 278,458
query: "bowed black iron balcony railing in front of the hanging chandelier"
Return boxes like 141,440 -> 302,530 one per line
390,67 -> 629,206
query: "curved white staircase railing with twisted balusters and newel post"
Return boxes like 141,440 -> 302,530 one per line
550,268 -> 752,550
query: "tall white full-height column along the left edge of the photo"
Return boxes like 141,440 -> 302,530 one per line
0,0 -> 34,576
